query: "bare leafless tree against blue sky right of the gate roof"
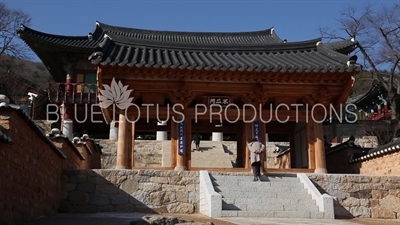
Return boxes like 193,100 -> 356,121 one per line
320,3 -> 400,124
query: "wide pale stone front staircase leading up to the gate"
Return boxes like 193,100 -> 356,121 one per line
210,172 -> 324,218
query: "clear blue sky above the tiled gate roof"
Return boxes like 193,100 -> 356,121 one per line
0,0 -> 400,59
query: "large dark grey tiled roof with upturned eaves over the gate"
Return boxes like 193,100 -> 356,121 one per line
18,22 -> 359,72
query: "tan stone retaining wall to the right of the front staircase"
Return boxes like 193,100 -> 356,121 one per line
308,174 -> 400,219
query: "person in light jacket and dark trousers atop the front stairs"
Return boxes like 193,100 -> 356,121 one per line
248,138 -> 265,181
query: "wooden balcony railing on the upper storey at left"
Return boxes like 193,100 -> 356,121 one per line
48,82 -> 98,104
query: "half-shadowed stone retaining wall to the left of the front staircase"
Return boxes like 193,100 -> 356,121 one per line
59,170 -> 199,214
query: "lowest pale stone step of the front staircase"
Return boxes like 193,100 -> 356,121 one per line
221,210 -> 324,219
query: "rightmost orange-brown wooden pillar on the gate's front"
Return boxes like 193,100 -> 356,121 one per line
313,122 -> 327,173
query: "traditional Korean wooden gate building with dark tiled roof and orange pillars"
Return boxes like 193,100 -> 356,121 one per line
18,22 -> 360,173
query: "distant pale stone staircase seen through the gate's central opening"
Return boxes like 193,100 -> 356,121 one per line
191,141 -> 233,168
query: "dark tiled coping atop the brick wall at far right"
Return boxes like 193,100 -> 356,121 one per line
350,138 -> 400,163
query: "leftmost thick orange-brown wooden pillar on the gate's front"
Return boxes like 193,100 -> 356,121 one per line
115,113 -> 129,169
